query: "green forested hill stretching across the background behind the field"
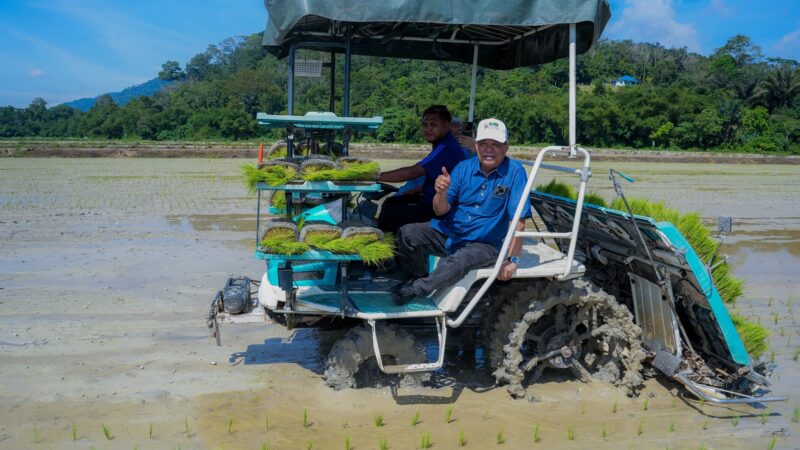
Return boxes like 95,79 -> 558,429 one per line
0,34 -> 800,153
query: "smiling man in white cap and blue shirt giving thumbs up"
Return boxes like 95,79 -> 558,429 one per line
394,119 -> 531,304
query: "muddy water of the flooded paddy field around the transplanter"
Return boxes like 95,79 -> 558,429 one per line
0,159 -> 800,449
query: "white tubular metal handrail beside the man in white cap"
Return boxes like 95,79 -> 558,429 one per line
447,146 -> 592,328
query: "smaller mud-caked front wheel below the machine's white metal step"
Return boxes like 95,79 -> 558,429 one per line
325,323 -> 430,391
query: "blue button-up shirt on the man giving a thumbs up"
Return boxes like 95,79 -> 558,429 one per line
431,158 -> 531,255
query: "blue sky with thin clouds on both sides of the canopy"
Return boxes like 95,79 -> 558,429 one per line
0,0 -> 800,107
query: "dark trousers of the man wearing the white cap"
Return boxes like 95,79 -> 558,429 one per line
397,222 -> 499,297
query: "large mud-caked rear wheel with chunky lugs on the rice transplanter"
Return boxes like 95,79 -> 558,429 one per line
492,278 -> 645,398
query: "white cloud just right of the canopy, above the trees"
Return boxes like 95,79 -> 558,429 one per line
608,0 -> 696,51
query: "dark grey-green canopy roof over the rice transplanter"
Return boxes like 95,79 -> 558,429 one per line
262,0 -> 611,69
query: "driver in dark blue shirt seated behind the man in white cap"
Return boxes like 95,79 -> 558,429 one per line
378,105 -> 466,232
